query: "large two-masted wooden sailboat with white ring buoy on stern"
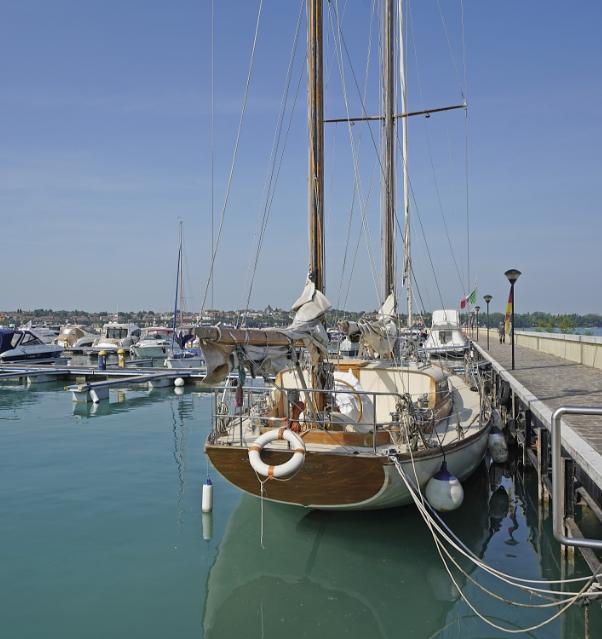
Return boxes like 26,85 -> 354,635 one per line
195,0 -> 492,510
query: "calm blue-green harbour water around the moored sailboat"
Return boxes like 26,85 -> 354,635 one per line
0,384 -> 602,639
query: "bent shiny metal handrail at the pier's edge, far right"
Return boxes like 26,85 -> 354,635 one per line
552,406 -> 602,550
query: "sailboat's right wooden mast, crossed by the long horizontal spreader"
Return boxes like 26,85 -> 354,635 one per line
381,0 -> 395,310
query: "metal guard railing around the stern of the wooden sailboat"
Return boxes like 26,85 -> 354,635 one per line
213,383 -> 442,453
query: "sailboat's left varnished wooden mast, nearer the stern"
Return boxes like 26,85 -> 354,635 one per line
307,0 -> 325,292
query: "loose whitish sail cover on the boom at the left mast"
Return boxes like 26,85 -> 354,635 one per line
201,280 -> 331,385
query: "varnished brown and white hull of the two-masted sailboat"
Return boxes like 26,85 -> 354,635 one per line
205,427 -> 489,510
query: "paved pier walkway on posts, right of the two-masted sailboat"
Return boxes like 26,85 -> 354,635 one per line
473,331 -> 602,571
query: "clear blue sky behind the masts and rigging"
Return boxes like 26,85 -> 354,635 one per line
0,0 -> 602,312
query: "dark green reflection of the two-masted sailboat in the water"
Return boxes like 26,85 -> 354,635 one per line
204,465 -> 492,639
